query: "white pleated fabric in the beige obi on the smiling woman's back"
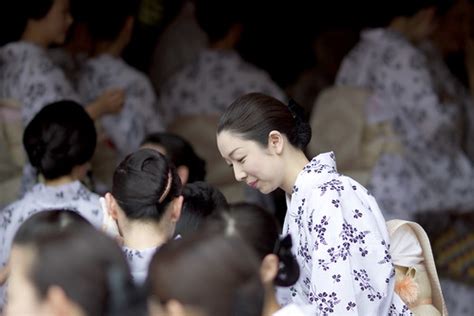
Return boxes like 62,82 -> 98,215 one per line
390,225 -> 424,267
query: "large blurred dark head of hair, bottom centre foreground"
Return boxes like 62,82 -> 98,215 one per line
147,233 -> 264,316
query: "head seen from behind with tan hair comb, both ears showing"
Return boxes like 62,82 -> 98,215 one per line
105,149 -> 183,241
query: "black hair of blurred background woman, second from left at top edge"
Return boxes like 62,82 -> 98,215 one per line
85,0 -> 139,41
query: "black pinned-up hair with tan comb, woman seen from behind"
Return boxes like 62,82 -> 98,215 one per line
112,149 -> 181,221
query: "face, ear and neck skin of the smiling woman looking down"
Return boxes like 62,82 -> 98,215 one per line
217,130 -> 309,195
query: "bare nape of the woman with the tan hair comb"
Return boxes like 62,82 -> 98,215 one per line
121,221 -> 169,250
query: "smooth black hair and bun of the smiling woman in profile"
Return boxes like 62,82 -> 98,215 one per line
217,93 -> 311,150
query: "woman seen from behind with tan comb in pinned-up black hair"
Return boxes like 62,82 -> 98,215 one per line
105,149 -> 183,283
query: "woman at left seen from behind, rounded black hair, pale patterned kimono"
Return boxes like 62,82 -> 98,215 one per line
0,101 -> 103,306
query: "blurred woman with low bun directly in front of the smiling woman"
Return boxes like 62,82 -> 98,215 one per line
206,203 -> 315,316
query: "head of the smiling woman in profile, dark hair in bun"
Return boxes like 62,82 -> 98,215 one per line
217,93 -> 311,194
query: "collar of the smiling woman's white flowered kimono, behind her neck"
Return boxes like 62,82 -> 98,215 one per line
292,151 -> 337,195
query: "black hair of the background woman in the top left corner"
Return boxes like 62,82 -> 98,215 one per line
0,0 -> 54,46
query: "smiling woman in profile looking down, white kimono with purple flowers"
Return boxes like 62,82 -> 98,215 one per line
217,93 -> 409,315
